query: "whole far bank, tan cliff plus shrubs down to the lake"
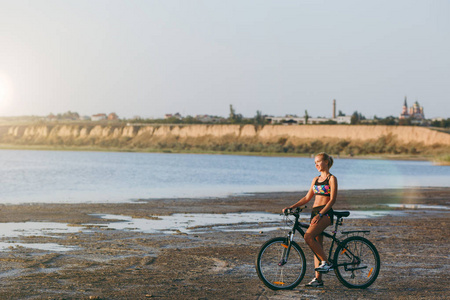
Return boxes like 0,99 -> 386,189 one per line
0,123 -> 450,155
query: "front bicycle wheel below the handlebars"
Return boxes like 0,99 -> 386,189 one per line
255,237 -> 306,290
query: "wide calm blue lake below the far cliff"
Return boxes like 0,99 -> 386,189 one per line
0,150 -> 450,204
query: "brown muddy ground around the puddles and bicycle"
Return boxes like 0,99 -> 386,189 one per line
0,188 -> 450,299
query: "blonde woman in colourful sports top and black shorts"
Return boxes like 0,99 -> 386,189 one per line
283,152 -> 337,287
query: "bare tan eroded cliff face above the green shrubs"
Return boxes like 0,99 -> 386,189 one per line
0,125 -> 450,147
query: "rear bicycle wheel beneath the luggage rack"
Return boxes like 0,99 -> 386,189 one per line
333,236 -> 380,289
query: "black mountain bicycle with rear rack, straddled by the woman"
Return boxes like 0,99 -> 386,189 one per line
255,206 -> 380,290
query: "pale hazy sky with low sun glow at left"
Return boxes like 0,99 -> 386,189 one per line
0,0 -> 450,118
